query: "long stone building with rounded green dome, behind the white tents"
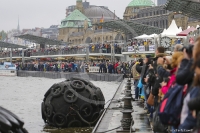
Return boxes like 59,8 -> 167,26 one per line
124,0 -> 200,30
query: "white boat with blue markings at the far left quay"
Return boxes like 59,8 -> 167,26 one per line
0,62 -> 17,76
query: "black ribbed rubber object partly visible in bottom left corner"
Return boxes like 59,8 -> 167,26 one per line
0,107 -> 28,133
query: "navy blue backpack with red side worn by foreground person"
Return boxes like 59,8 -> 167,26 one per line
158,84 -> 187,126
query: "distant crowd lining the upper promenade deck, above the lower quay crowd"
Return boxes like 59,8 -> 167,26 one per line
0,44 -> 122,57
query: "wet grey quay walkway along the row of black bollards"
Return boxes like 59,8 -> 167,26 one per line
92,79 -> 152,133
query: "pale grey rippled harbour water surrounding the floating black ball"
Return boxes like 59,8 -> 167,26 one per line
0,76 -> 120,133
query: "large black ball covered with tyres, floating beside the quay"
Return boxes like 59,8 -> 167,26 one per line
41,78 -> 105,127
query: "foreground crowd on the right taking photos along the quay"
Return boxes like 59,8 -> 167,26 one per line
131,37 -> 200,133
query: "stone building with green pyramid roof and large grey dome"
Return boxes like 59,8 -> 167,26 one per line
58,0 -> 120,45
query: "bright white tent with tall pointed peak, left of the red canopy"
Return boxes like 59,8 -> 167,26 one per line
161,20 -> 182,37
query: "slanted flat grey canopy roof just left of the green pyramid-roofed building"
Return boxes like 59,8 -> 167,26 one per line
15,34 -> 69,45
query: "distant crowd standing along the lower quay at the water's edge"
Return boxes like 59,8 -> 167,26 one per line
16,61 -> 134,75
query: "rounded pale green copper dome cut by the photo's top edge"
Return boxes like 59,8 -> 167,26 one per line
128,0 -> 154,7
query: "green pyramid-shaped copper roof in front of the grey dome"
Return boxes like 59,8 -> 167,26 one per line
59,9 -> 92,28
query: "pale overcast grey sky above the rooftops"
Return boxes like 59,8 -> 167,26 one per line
0,0 -> 156,31
